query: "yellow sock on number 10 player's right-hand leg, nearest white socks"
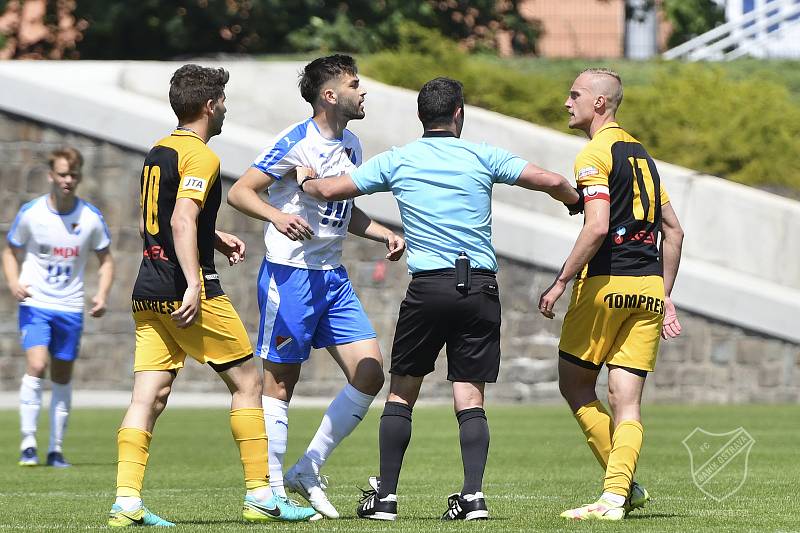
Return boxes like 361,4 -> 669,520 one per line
231,408 -> 269,490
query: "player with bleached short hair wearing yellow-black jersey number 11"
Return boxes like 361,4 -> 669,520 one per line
539,69 -> 683,520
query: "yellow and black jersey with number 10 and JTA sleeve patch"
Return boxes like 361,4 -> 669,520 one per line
133,129 -> 224,300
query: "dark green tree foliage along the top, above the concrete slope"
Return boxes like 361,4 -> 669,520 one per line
0,0 -> 539,59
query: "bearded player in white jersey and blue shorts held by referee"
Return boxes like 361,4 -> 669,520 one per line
228,55 -> 405,518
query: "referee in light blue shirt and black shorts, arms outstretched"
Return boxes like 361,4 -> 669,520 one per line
297,78 -> 582,520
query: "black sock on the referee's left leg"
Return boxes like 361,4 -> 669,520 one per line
378,402 -> 411,499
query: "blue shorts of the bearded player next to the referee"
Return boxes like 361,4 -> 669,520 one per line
255,260 -> 376,363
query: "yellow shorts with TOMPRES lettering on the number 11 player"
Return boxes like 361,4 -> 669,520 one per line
558,276 -> 664,372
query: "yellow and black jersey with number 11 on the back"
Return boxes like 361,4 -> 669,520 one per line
575,122 -> 669,277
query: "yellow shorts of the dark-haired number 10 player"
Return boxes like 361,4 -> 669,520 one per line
132,295 -> 253,372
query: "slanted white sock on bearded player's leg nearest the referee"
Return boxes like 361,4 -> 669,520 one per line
298,383 -> 375,474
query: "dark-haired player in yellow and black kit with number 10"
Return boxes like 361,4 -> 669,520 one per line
108,65 -> 319,527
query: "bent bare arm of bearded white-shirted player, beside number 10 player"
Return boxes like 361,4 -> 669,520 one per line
228,167 -> 314,241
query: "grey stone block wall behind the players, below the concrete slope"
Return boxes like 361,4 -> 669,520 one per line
0,113 -> 800,403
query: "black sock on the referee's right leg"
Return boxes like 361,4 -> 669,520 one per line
456,407 -> 489,494
